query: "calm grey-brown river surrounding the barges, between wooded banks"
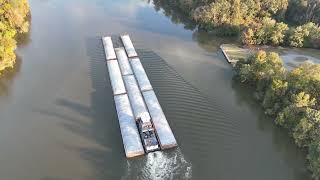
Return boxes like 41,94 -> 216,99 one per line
0,0 -> 310,180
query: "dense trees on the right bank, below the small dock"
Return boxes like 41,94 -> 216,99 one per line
235,51 -> 320,179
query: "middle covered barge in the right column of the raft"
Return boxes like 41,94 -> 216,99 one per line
130,58 -> 152,91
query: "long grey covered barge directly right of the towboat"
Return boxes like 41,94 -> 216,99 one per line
142,91 -> 177,149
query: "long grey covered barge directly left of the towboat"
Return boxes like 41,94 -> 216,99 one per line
114,94 -> 144,158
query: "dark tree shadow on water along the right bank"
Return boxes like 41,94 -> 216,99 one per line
232,78 -> 311,180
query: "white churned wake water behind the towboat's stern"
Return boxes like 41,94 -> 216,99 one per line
122,148 -> 192,180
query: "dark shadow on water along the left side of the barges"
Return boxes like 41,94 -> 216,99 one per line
38,37 -> 126,180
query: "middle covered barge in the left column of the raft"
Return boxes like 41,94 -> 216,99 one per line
107,60 -> 126,95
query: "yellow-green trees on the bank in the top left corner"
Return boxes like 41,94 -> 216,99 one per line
0,0 -> 30,76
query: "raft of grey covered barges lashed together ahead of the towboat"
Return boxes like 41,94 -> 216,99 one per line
102,35 -> 177,158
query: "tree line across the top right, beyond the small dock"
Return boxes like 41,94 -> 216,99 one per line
156,0 -> 320,48
